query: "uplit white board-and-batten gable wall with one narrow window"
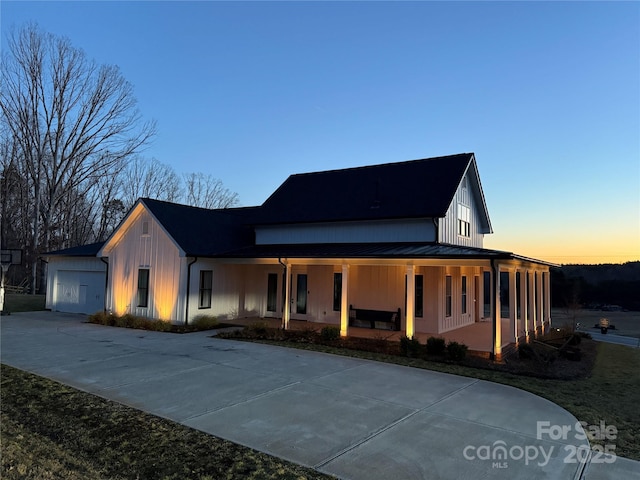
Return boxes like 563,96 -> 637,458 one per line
106,210 -> 187,323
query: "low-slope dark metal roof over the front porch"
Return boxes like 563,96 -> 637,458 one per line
218,242 -> 513,259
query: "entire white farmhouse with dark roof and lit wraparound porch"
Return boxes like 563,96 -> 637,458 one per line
47,153 -> 551,355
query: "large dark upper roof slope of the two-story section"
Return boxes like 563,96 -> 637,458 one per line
260,153 -> 474,224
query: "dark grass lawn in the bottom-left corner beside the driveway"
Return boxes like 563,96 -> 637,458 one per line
0,365 -> 332,480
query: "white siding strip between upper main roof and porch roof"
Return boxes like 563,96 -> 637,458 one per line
256,218 -> 436,245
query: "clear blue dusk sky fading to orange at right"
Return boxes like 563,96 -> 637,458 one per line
0,1 -> 640,263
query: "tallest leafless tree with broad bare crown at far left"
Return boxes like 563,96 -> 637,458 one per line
0,24 -> 155,292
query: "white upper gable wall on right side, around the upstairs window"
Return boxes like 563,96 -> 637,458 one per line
438,175 -> 484,248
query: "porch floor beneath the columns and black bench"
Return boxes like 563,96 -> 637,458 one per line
228,317 -> 515,352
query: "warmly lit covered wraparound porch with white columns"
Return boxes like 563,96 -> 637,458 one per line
222,244 -> 551,358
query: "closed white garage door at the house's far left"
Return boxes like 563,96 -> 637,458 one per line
53,270 -> 105,313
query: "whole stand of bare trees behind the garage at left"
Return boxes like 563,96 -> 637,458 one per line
0,24 -> 239,293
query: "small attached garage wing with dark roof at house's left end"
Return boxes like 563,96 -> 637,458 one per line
45,243 -> 107,314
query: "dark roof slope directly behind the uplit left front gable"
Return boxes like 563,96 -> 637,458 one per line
141,198 -> 259,257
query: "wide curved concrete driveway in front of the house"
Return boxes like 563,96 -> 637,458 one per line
0,312 -> 640,480
